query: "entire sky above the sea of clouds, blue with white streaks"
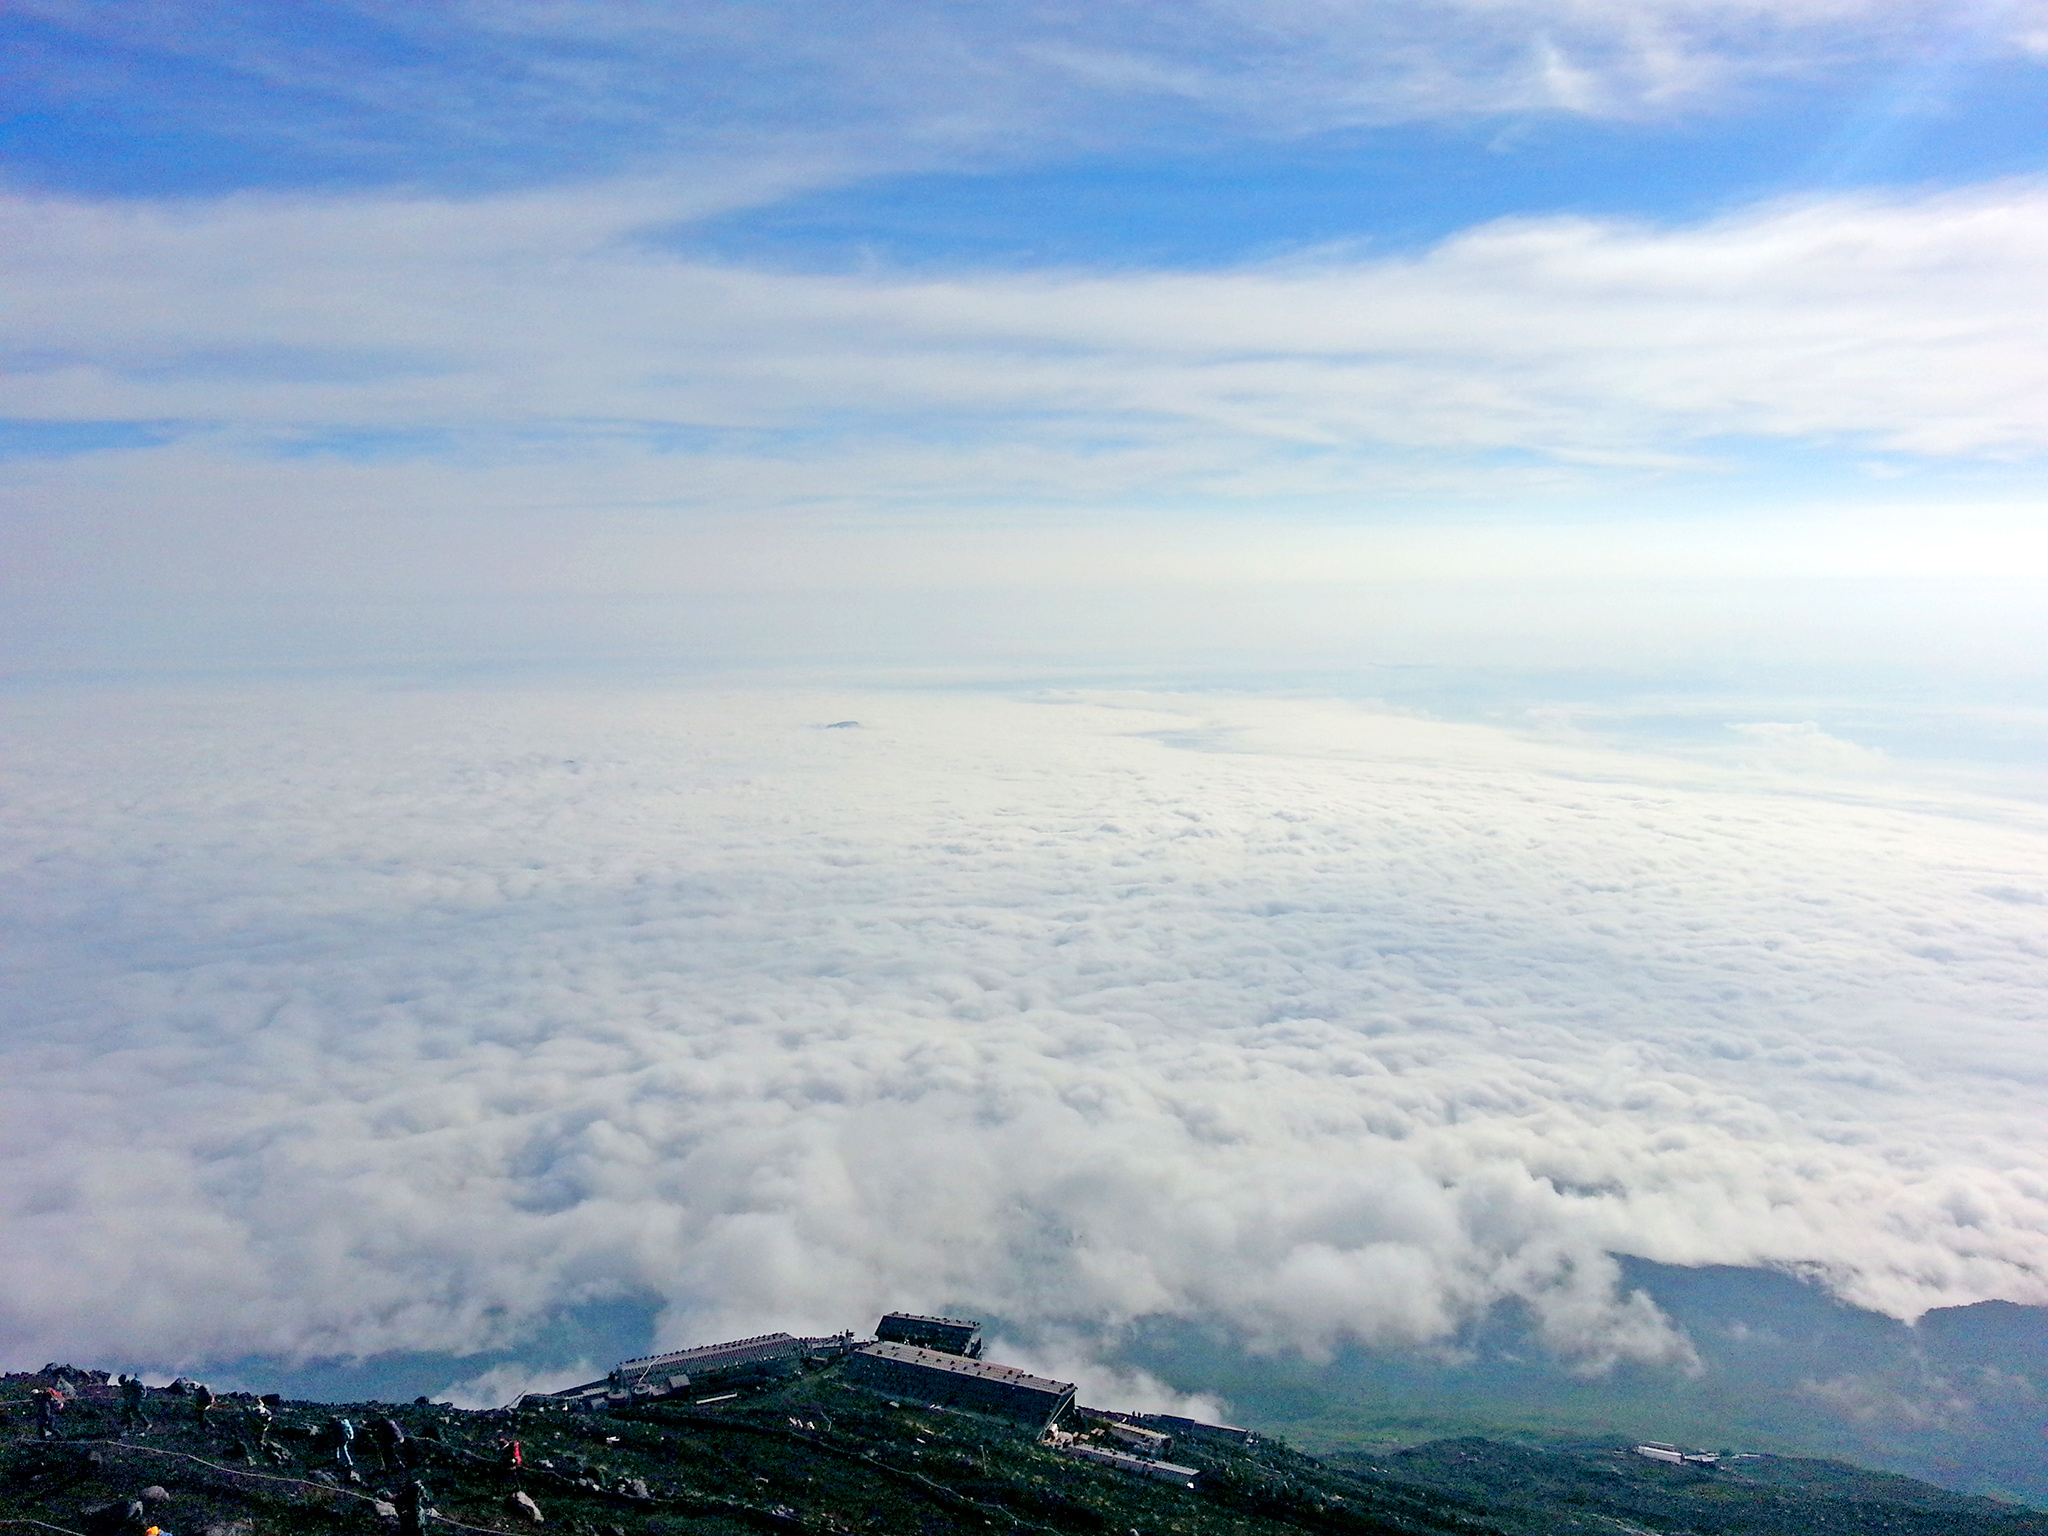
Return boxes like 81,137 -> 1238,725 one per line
0,0 -> 2048,666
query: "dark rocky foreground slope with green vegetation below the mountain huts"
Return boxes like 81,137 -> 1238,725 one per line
0,1366 -> 2048,1536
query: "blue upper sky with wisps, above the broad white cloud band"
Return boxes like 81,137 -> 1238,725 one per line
6,2 -> 2044,208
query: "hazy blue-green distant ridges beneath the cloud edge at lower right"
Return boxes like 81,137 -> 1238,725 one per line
1126,1260 -> 2048,1507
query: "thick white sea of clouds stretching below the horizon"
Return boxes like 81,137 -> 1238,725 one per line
0,684 -> 2048,1384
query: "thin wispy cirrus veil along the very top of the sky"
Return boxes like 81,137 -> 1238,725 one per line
14,0 -> 2044,165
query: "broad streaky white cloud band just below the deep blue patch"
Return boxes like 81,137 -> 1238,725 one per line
16,182 -> 2048,462
